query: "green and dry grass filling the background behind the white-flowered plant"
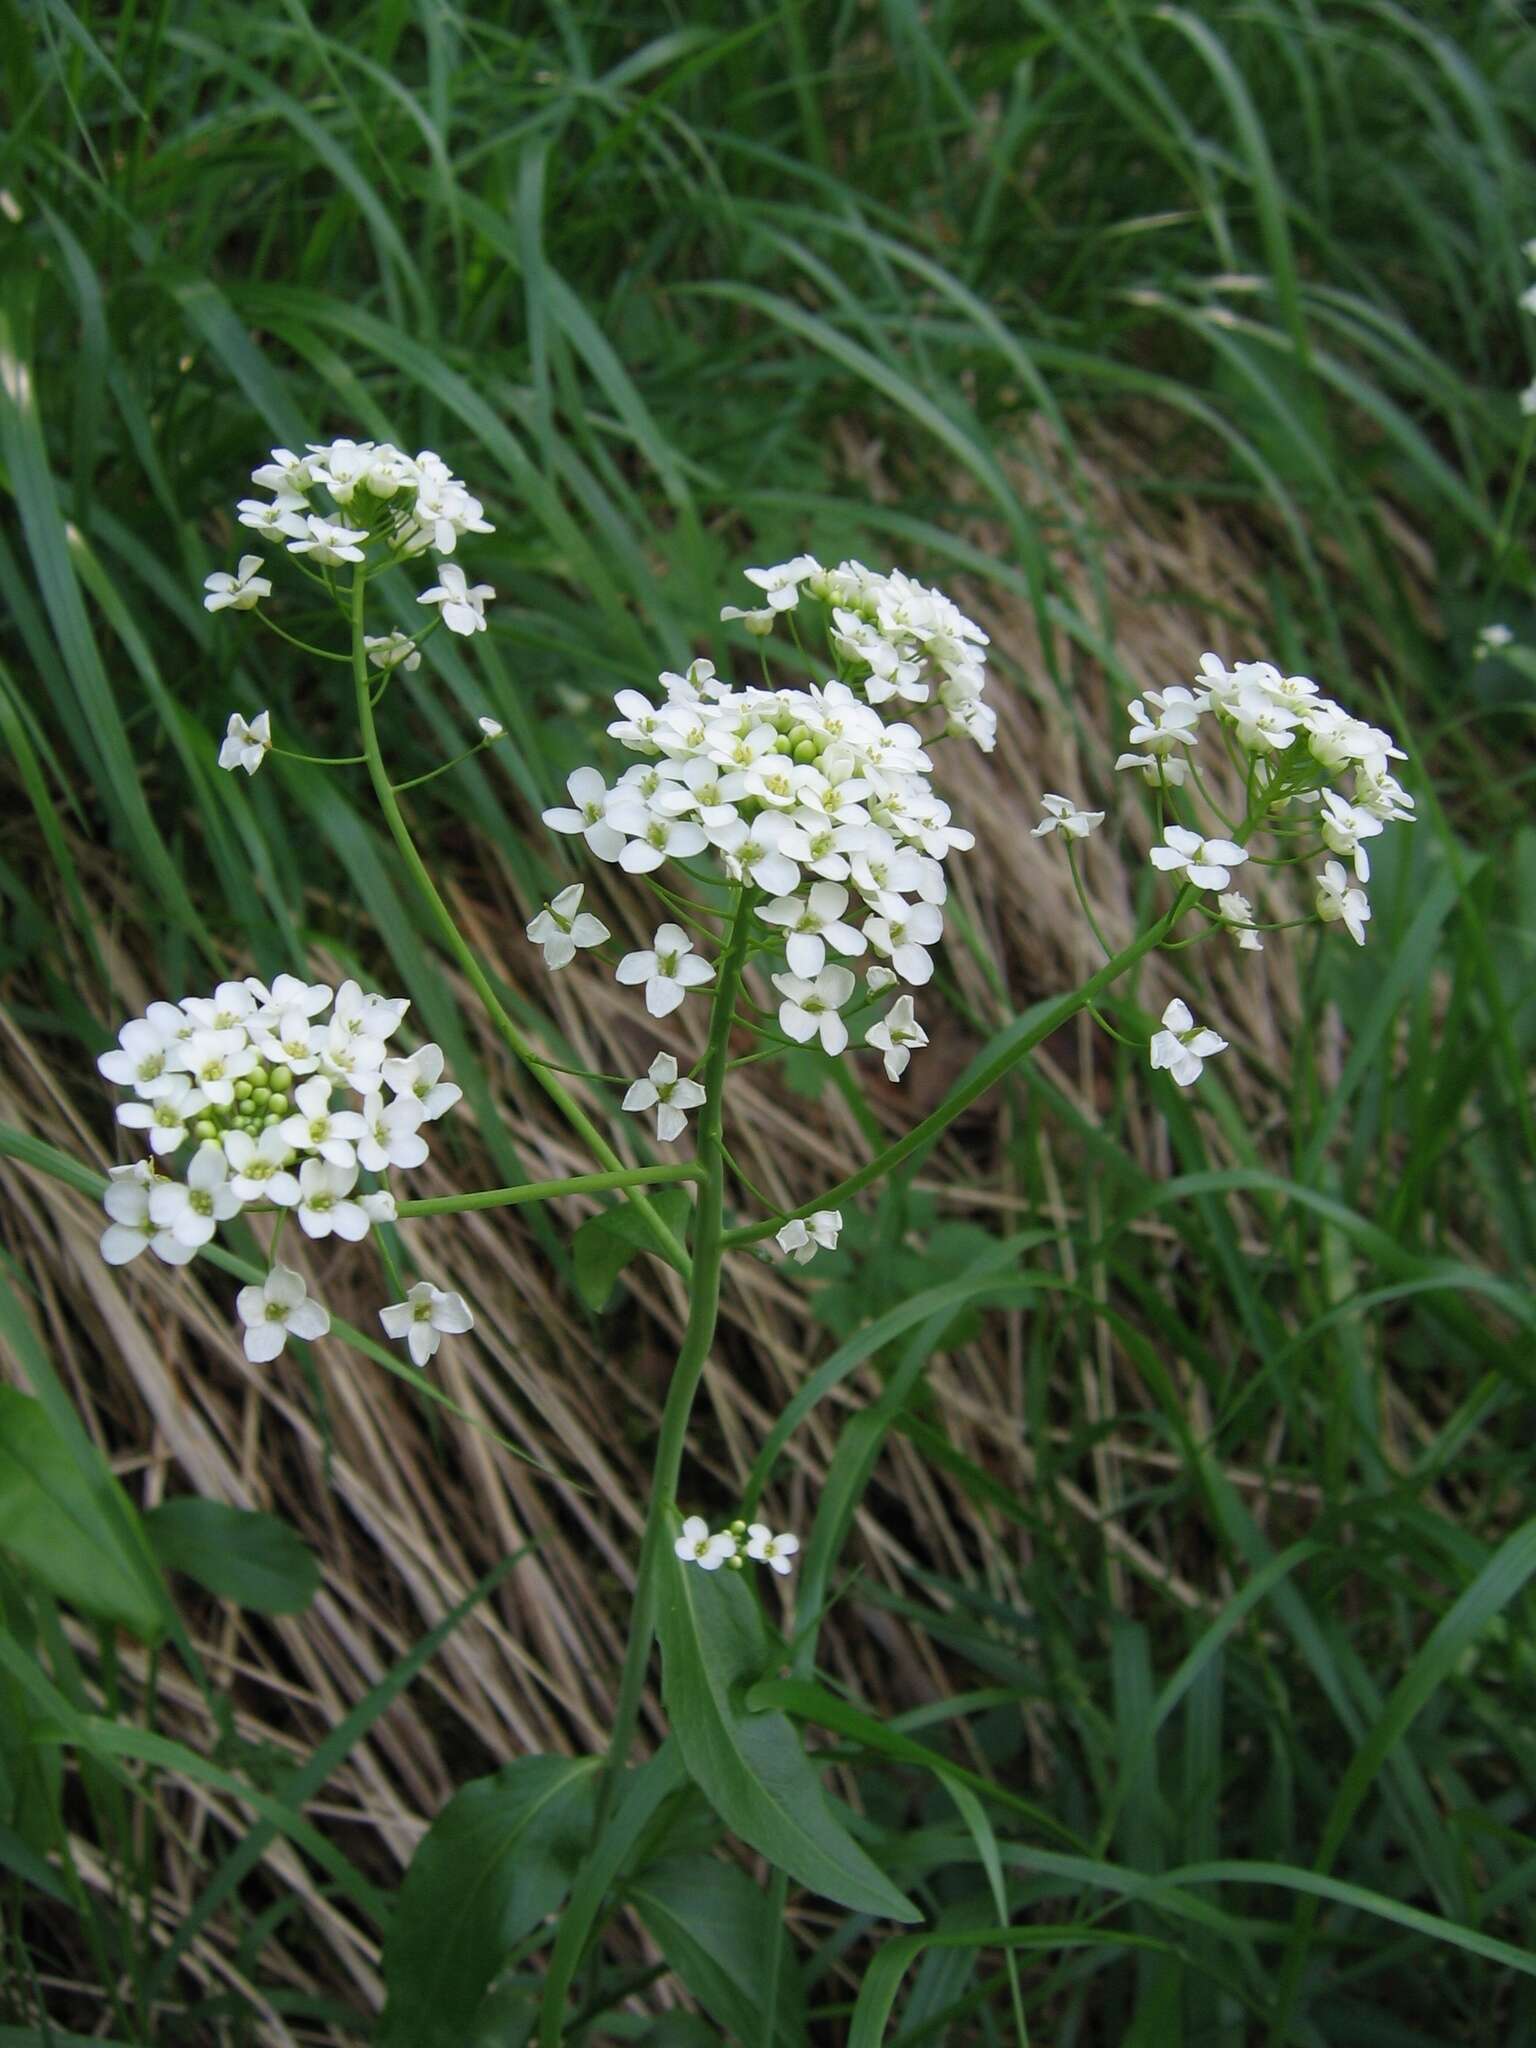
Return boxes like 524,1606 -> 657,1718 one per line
0,0 -> 1536,2048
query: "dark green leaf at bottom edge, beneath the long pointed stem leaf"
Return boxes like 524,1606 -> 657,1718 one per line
625,1855 -> 805,2048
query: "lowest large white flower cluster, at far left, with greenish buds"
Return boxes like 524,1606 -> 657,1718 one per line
96,975 -> 461,1358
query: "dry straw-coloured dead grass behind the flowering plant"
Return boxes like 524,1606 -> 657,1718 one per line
0,423 -> 1417,2042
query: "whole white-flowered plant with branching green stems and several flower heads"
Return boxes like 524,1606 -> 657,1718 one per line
90,440 -> 1413,2038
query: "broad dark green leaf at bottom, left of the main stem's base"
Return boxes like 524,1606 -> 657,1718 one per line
377,1757 -> 598,2048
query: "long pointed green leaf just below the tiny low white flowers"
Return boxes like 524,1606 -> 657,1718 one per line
657,1550 -> 920,1921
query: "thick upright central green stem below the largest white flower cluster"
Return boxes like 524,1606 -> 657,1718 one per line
596,883 -> 752,1829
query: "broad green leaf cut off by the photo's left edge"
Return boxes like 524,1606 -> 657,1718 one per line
0,1386 -> 166,1642
